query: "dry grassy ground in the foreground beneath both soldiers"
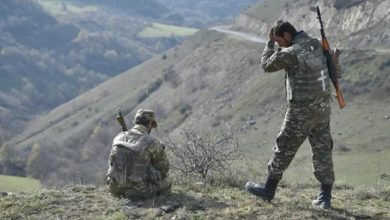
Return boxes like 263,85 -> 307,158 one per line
0,185 -> 390,220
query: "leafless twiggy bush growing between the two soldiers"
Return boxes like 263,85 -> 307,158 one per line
166,128 -> 241,183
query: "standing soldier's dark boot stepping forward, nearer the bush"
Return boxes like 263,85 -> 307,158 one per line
245,177 -> 279,202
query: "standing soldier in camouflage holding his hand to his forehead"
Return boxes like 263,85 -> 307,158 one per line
246,20 -> 335,209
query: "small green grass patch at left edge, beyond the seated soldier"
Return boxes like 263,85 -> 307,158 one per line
0,175 -> 41,192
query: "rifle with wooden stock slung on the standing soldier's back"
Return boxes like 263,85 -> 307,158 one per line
317,6 -> 345,109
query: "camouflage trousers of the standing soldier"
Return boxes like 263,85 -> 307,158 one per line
268,97 -> 335,184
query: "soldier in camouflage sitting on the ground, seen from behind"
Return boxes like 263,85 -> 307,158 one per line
107,109 -> 171,198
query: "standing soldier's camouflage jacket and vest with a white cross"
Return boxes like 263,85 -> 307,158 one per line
261,31 -> 331,100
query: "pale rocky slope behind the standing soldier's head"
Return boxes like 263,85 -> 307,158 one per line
234,0 -> 390,49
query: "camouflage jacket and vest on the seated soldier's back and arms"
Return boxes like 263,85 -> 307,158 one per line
108,125 -> 169,186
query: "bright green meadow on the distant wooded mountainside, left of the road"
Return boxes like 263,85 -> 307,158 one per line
139,23 -> 198,38
